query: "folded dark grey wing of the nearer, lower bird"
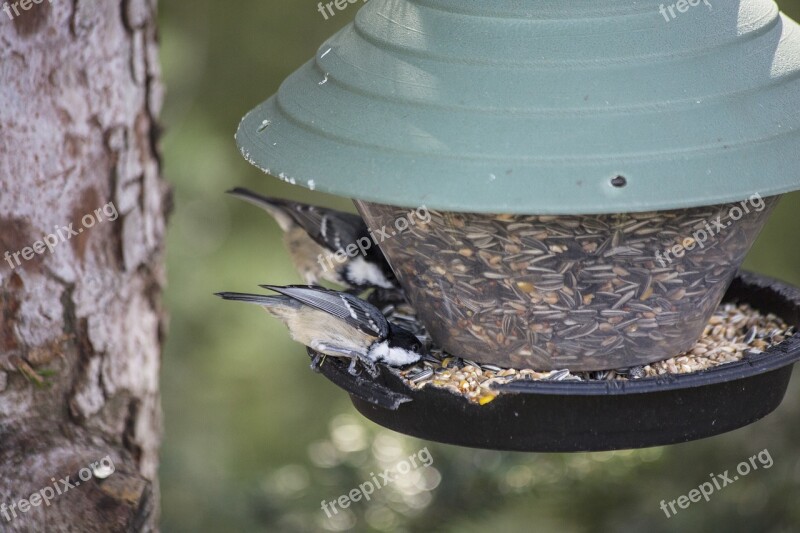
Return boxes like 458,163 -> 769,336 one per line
261,285 -> 389,339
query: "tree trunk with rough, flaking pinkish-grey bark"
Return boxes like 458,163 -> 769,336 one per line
0,0 -> 170,532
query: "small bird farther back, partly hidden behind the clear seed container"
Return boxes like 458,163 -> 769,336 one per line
228,187 -> 397,292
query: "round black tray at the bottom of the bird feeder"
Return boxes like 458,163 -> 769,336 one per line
310,272 -> 800,452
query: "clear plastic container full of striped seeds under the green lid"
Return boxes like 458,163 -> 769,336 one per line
356,195 -> 779,370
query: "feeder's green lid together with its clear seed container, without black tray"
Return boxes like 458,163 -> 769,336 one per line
237,0 -> 800,448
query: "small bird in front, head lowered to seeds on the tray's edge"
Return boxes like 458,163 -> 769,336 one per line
217,285 -> 422,377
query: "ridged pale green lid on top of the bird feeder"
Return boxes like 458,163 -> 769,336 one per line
236,0 -> 800,214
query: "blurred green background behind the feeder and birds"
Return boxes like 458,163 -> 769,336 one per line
160,0 -> 800,533
